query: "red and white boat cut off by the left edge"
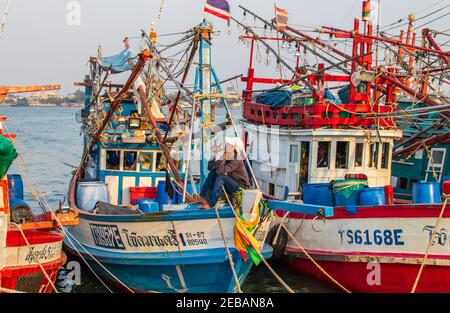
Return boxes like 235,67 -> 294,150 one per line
0,116 -> 76,293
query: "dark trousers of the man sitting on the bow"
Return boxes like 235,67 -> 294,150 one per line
200,171 -> 241,207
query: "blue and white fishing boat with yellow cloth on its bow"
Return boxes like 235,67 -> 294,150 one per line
65,23 -> 271,293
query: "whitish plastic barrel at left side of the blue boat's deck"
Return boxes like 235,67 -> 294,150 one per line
77,181 -> 109,211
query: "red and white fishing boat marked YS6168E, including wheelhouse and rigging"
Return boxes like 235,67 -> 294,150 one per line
236,1 -> 450,292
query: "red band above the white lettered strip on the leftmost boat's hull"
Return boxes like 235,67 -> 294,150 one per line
6,229 -> 64,247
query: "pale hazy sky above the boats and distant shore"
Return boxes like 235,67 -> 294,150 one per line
0,0 -> 450,93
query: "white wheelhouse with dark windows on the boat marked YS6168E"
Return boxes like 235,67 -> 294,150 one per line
243,122 -> 402,198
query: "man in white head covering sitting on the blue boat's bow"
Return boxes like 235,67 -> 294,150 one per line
195,137 -> 249,209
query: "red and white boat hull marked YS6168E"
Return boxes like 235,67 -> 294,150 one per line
279,205 -> 450,292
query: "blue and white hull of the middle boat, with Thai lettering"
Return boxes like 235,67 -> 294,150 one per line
65,210 -> 271,293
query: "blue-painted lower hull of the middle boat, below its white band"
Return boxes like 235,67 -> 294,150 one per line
66,233 -> 272,293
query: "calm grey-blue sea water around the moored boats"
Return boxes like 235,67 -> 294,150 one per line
0,107 -> 336,293
